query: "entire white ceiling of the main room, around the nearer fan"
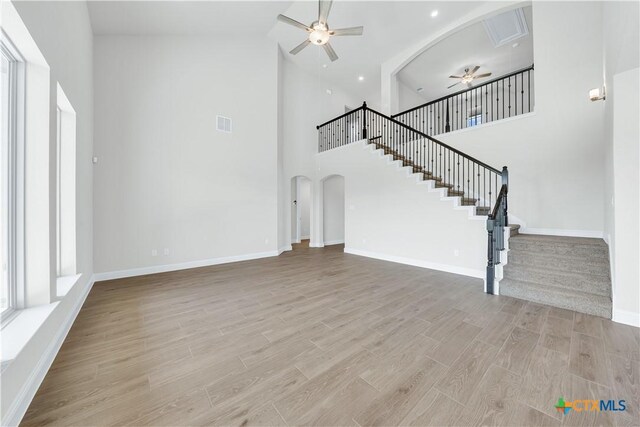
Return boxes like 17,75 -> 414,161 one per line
88,0 -> 496,102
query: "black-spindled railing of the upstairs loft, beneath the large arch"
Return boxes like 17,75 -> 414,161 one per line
391,65 -> 534,135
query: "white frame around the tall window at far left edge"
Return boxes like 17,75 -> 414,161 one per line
0,31 -> 26,327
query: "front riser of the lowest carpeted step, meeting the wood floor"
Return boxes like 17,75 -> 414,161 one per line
500,286 -> 611,319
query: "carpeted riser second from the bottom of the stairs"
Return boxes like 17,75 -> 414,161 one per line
504,268 -> 611,297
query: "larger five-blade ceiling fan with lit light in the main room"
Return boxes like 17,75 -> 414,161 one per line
278,0 -> 364,62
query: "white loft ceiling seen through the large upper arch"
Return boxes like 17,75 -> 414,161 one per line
398,6 -> 533,101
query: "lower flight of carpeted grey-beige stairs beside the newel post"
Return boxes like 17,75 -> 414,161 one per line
500,234 -> 611,319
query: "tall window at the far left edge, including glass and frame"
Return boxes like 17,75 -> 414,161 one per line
0,34 -> 23,321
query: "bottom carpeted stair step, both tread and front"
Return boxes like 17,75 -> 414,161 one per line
500,278 -> 611,319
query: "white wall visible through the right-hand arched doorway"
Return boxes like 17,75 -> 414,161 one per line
322,176 -> 344,245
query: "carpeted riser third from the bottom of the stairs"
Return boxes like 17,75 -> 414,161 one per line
509,254 -> 609,278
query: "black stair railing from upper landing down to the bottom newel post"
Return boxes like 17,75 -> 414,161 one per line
317,102 -> 508,293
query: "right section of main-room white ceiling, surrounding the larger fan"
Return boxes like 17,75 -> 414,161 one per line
270,0 -> 484,102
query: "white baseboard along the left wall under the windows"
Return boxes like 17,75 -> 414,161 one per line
2,276 -> 95,426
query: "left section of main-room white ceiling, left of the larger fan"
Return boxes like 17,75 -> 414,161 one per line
88,0 -> 292,35
